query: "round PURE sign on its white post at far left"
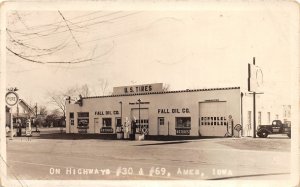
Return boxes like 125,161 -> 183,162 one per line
5,90 -> 19,140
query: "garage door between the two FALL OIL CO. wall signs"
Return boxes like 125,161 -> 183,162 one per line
131,108 -> 149,134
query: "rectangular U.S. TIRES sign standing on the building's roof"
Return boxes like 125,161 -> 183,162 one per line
113,83 -> 163,95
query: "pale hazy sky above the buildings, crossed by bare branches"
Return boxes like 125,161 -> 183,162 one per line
6,3 -> 296,111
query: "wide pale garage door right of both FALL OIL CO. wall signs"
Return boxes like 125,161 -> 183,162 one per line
199,102 -> 227,136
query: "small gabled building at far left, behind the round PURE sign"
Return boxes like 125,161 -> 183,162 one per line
6,99 -> 36,126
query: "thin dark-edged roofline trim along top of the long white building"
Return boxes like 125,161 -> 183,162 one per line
82,87 -> 240,99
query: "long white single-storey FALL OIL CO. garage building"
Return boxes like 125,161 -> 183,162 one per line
66,83 -> 290,138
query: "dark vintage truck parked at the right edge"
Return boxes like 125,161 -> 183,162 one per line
256,120 -> 291,138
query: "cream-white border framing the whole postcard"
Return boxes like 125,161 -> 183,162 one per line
0,0 -> 300,187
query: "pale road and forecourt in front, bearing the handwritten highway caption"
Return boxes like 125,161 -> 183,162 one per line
3,131 -> 290,186
